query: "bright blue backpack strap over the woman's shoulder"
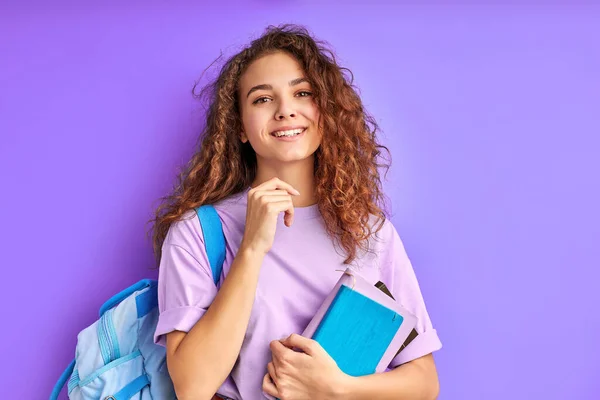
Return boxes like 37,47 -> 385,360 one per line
196,204 -> 225,285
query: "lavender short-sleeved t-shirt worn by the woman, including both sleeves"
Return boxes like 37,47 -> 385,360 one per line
154,189 -> 442,400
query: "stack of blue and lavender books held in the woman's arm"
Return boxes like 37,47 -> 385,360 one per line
302,268 -> 417,376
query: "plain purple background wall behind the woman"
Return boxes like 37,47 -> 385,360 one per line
0,1 -> 600,400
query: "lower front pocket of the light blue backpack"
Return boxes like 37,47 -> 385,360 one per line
69,350 -> 151,400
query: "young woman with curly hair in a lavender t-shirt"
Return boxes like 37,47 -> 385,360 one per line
154,25 -> 441,400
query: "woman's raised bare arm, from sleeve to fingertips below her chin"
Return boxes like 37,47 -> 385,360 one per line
166,178 -> 298,400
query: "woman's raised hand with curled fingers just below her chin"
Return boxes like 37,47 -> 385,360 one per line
240,178 -> 300,254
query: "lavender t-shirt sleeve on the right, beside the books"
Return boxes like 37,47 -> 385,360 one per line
381,220 -> 442,368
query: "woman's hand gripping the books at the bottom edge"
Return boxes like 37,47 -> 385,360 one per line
263,334 -> 349,400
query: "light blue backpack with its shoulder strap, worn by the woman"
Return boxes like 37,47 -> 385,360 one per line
50,205 -> 225,400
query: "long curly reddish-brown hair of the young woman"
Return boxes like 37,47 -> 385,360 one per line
149,24 -> 390,265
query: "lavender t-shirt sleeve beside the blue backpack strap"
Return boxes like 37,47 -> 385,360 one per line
154,212 -> 217,346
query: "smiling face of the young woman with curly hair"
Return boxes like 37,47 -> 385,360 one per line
238,52 -> 321,168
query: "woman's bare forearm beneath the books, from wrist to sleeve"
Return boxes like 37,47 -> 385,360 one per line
340,354 -> 439,400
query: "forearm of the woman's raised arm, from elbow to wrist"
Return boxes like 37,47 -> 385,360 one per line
167,250 -> 264,399
